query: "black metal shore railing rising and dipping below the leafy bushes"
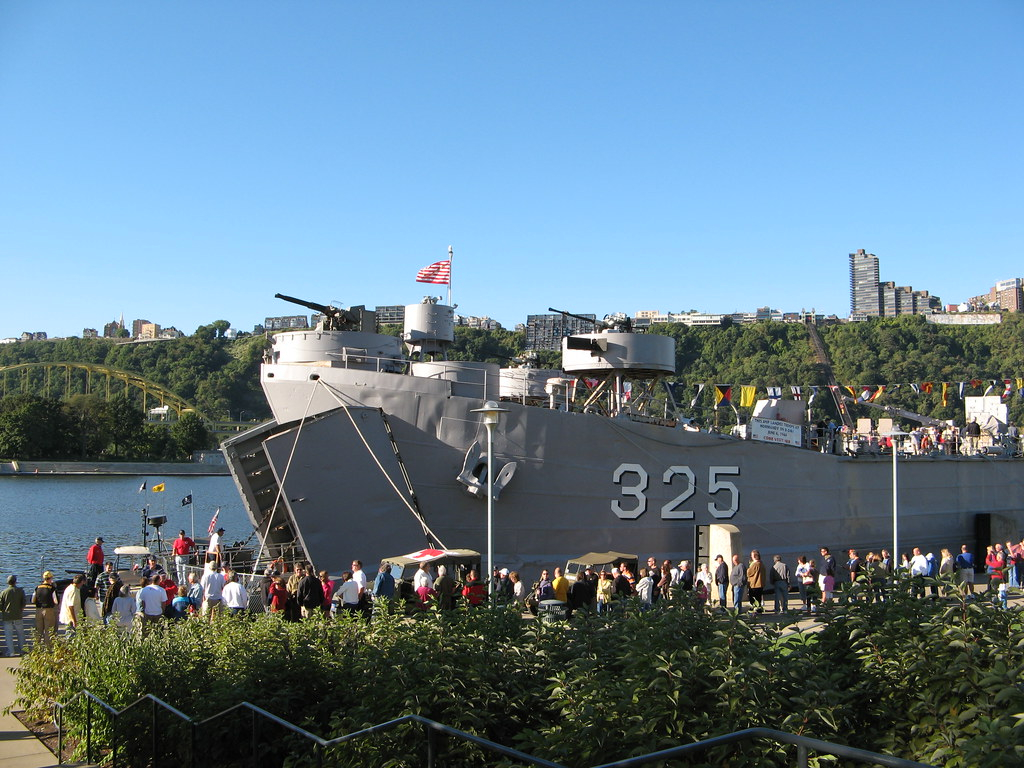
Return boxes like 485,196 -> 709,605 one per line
53,690 -> 930,768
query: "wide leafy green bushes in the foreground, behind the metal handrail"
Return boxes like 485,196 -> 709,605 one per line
17,584 -> 1024,768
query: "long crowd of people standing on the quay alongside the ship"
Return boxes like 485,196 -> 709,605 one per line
0,530 -> 1024,655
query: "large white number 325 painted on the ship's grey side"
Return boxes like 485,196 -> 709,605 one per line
611,464 -> 739,520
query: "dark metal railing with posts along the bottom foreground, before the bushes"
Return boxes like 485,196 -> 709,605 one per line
46,689 -> 929,768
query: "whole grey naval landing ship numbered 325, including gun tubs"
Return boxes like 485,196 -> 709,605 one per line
223,294 -> 1024,573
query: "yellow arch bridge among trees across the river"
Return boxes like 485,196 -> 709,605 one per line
0,362 -> 211,426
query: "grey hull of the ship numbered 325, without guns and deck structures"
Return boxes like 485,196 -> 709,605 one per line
225,365 -> 1024,572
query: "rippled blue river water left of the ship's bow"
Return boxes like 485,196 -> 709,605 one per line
0,475 -> 252,589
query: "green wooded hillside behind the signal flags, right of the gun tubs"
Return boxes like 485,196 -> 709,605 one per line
652,314 -> 1024,424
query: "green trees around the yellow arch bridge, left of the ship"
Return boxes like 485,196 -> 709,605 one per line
0,321 -> 260,461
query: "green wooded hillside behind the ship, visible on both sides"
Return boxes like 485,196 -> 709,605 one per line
6,314 -> 1024,459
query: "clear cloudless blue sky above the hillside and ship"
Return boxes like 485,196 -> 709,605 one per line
0,0 -> 1024,337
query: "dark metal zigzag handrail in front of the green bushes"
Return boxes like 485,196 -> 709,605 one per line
46,689 -> 934,768
